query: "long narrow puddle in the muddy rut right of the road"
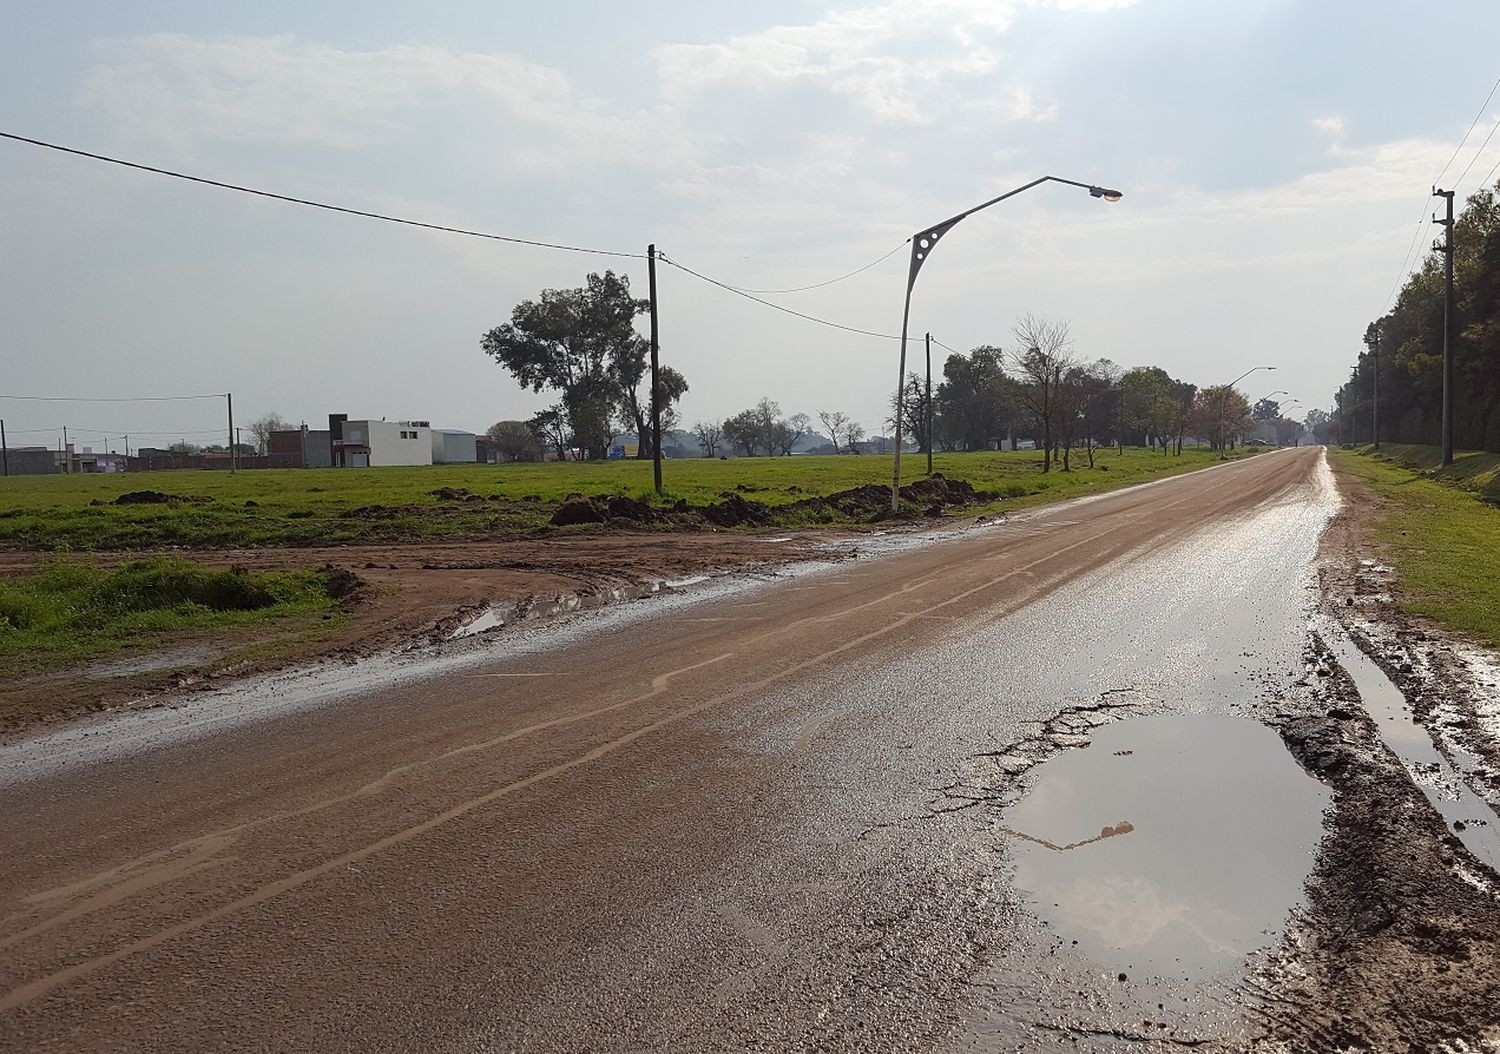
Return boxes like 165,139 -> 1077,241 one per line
1323,625 -> 1500,871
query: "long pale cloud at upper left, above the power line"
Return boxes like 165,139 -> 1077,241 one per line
80,33 -> 683,169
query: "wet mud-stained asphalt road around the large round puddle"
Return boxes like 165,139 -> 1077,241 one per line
0,450 -> 1337,1051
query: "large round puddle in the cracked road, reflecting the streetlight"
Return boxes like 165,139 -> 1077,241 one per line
1005,715 -> 1329,979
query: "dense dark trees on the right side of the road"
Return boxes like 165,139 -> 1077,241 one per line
1338,184 -> 1500,451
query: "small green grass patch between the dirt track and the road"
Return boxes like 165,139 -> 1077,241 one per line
0,556 -> 336,676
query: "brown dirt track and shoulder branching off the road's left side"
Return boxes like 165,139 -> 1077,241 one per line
0,531 -> 852,736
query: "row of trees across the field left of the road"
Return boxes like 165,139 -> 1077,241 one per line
480,271 -> 1302,471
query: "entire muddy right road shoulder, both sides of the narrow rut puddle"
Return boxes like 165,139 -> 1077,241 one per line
1248,458 -> 1500,1054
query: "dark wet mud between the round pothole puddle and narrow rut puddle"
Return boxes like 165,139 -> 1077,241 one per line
1247,639 -> 1500,1054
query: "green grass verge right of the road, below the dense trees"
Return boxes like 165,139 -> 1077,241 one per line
1332,447 -> 1500,646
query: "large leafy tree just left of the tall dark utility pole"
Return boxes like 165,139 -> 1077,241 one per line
480,271 -> 650,457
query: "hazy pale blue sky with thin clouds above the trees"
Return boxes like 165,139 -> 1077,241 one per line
0,0 -> 1500,445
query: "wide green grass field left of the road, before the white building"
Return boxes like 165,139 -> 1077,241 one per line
0,448 -> 1254,550
